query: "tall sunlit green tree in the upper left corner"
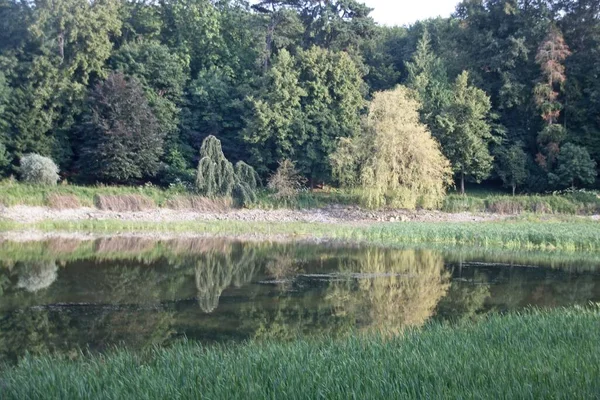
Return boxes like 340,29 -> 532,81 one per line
2,0 -> 121,165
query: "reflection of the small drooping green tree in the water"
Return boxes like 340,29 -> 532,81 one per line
195,243 -> 256,313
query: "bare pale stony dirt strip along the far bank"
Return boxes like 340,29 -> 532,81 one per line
0,206 -> 509,223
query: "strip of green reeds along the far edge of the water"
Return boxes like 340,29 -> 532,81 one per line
0,219 -> 600,252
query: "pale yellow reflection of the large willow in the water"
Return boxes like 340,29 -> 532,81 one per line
326,248 -> 450,334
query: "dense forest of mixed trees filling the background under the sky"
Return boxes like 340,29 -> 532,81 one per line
0,0 -> 600,192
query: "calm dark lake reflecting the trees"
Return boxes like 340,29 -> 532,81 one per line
0,237 -> 600,360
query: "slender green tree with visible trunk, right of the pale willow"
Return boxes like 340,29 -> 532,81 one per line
437,71 -> 495,194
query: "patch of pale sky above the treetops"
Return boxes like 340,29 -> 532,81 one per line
361,0 -> 459,26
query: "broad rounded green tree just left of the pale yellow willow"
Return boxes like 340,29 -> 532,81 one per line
245,47 -> 364,186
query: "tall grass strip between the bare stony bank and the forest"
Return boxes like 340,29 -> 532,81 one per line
0,180 -> 600,215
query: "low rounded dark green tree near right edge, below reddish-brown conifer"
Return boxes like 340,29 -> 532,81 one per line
551,143 -> 597,189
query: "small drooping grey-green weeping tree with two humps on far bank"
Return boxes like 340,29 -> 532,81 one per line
196,135 -> 260,206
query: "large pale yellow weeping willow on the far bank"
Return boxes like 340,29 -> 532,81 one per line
331,86 -> 452,208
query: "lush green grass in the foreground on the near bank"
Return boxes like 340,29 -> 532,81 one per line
1,307 -> 600,399
